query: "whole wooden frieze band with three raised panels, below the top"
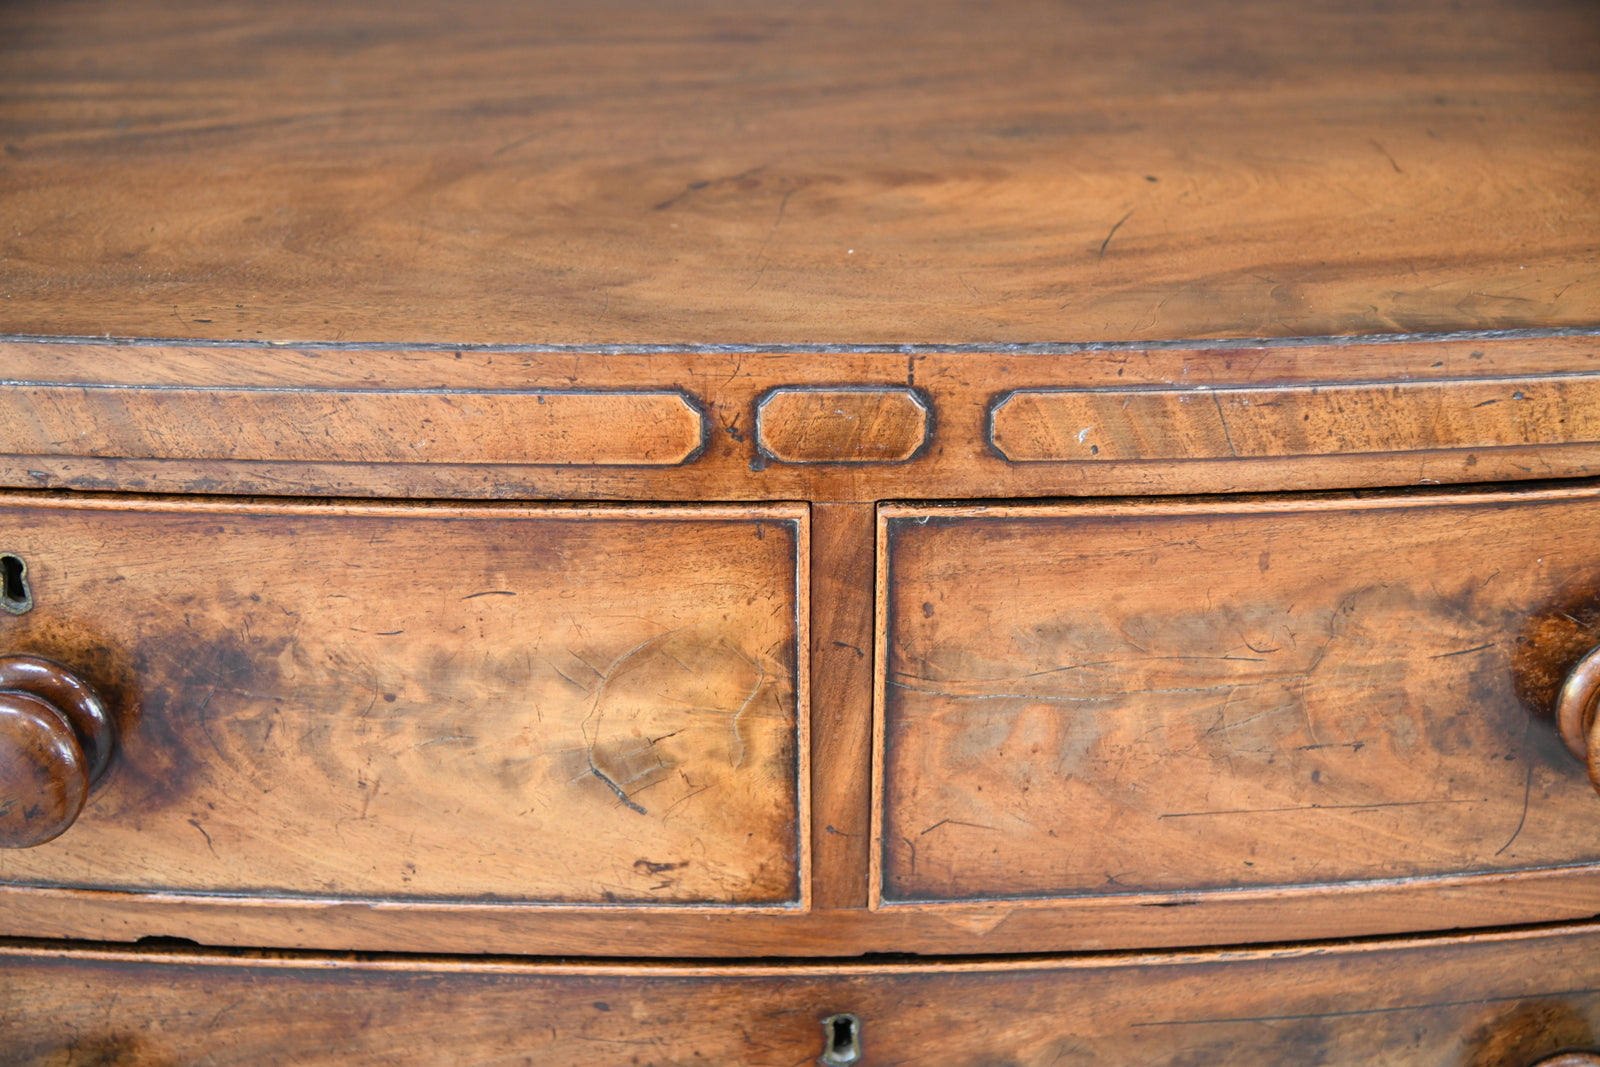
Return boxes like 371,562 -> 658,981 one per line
0,334 -> 1600,502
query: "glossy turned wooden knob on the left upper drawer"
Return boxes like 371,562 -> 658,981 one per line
0,656 -> 117,848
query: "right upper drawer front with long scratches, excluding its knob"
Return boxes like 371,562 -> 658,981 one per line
874,490 -> 1600,908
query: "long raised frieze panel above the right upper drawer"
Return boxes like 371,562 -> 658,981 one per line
989,374 -> 1600,462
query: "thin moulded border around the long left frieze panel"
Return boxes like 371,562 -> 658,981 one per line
0,379 -> 712,470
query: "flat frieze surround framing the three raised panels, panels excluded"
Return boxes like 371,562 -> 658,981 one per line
0,334 -> 1600,502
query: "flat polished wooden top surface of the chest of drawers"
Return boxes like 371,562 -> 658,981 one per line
0,0 -> 1600,346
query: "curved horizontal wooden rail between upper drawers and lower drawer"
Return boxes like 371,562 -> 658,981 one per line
9,865 -> 1600,958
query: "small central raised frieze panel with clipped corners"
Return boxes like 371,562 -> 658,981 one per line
755,387 -> 931,462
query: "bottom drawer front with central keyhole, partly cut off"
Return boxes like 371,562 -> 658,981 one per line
0,925 -> 1600,1067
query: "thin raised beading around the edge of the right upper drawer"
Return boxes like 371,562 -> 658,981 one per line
867,486 -> 1600,921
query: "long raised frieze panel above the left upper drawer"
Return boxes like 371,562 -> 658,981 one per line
0,382 -> 707,467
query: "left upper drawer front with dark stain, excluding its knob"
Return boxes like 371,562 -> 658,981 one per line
0,498 -> 806,907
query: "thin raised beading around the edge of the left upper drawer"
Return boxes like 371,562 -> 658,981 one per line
0,491 -> 813,917
